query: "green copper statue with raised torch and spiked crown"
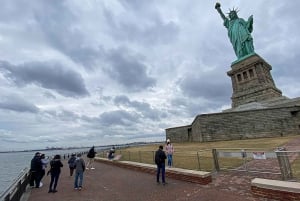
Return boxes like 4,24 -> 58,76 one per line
215,3 -> 254,59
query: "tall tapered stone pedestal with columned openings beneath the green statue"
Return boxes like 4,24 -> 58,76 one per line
227,54 -> 282,108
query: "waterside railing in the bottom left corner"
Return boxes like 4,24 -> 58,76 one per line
0,168 -> 30,201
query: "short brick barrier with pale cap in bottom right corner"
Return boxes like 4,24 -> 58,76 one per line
251,178 -> 300,201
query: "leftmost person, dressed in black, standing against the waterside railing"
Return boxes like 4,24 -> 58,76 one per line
29,152 -> 42,188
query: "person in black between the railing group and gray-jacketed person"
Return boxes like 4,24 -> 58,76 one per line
48,155 -> 63,193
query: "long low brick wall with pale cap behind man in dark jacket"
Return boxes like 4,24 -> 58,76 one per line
95,157 -> 212,185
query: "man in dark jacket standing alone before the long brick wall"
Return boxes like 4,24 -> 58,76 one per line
155,145 -> 167,185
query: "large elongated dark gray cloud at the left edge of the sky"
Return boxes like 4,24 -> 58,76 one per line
0,61 -> 89,97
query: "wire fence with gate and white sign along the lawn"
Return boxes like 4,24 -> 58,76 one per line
98,148 -> 300,181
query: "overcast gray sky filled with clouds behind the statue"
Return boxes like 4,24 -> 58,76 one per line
0,0 -> 300,151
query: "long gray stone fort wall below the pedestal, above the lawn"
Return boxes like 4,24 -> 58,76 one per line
166,105 -> 300,142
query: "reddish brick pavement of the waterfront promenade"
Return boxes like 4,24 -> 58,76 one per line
28,138 -> 300,201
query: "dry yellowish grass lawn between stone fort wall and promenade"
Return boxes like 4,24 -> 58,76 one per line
97,136 -> 299,171
